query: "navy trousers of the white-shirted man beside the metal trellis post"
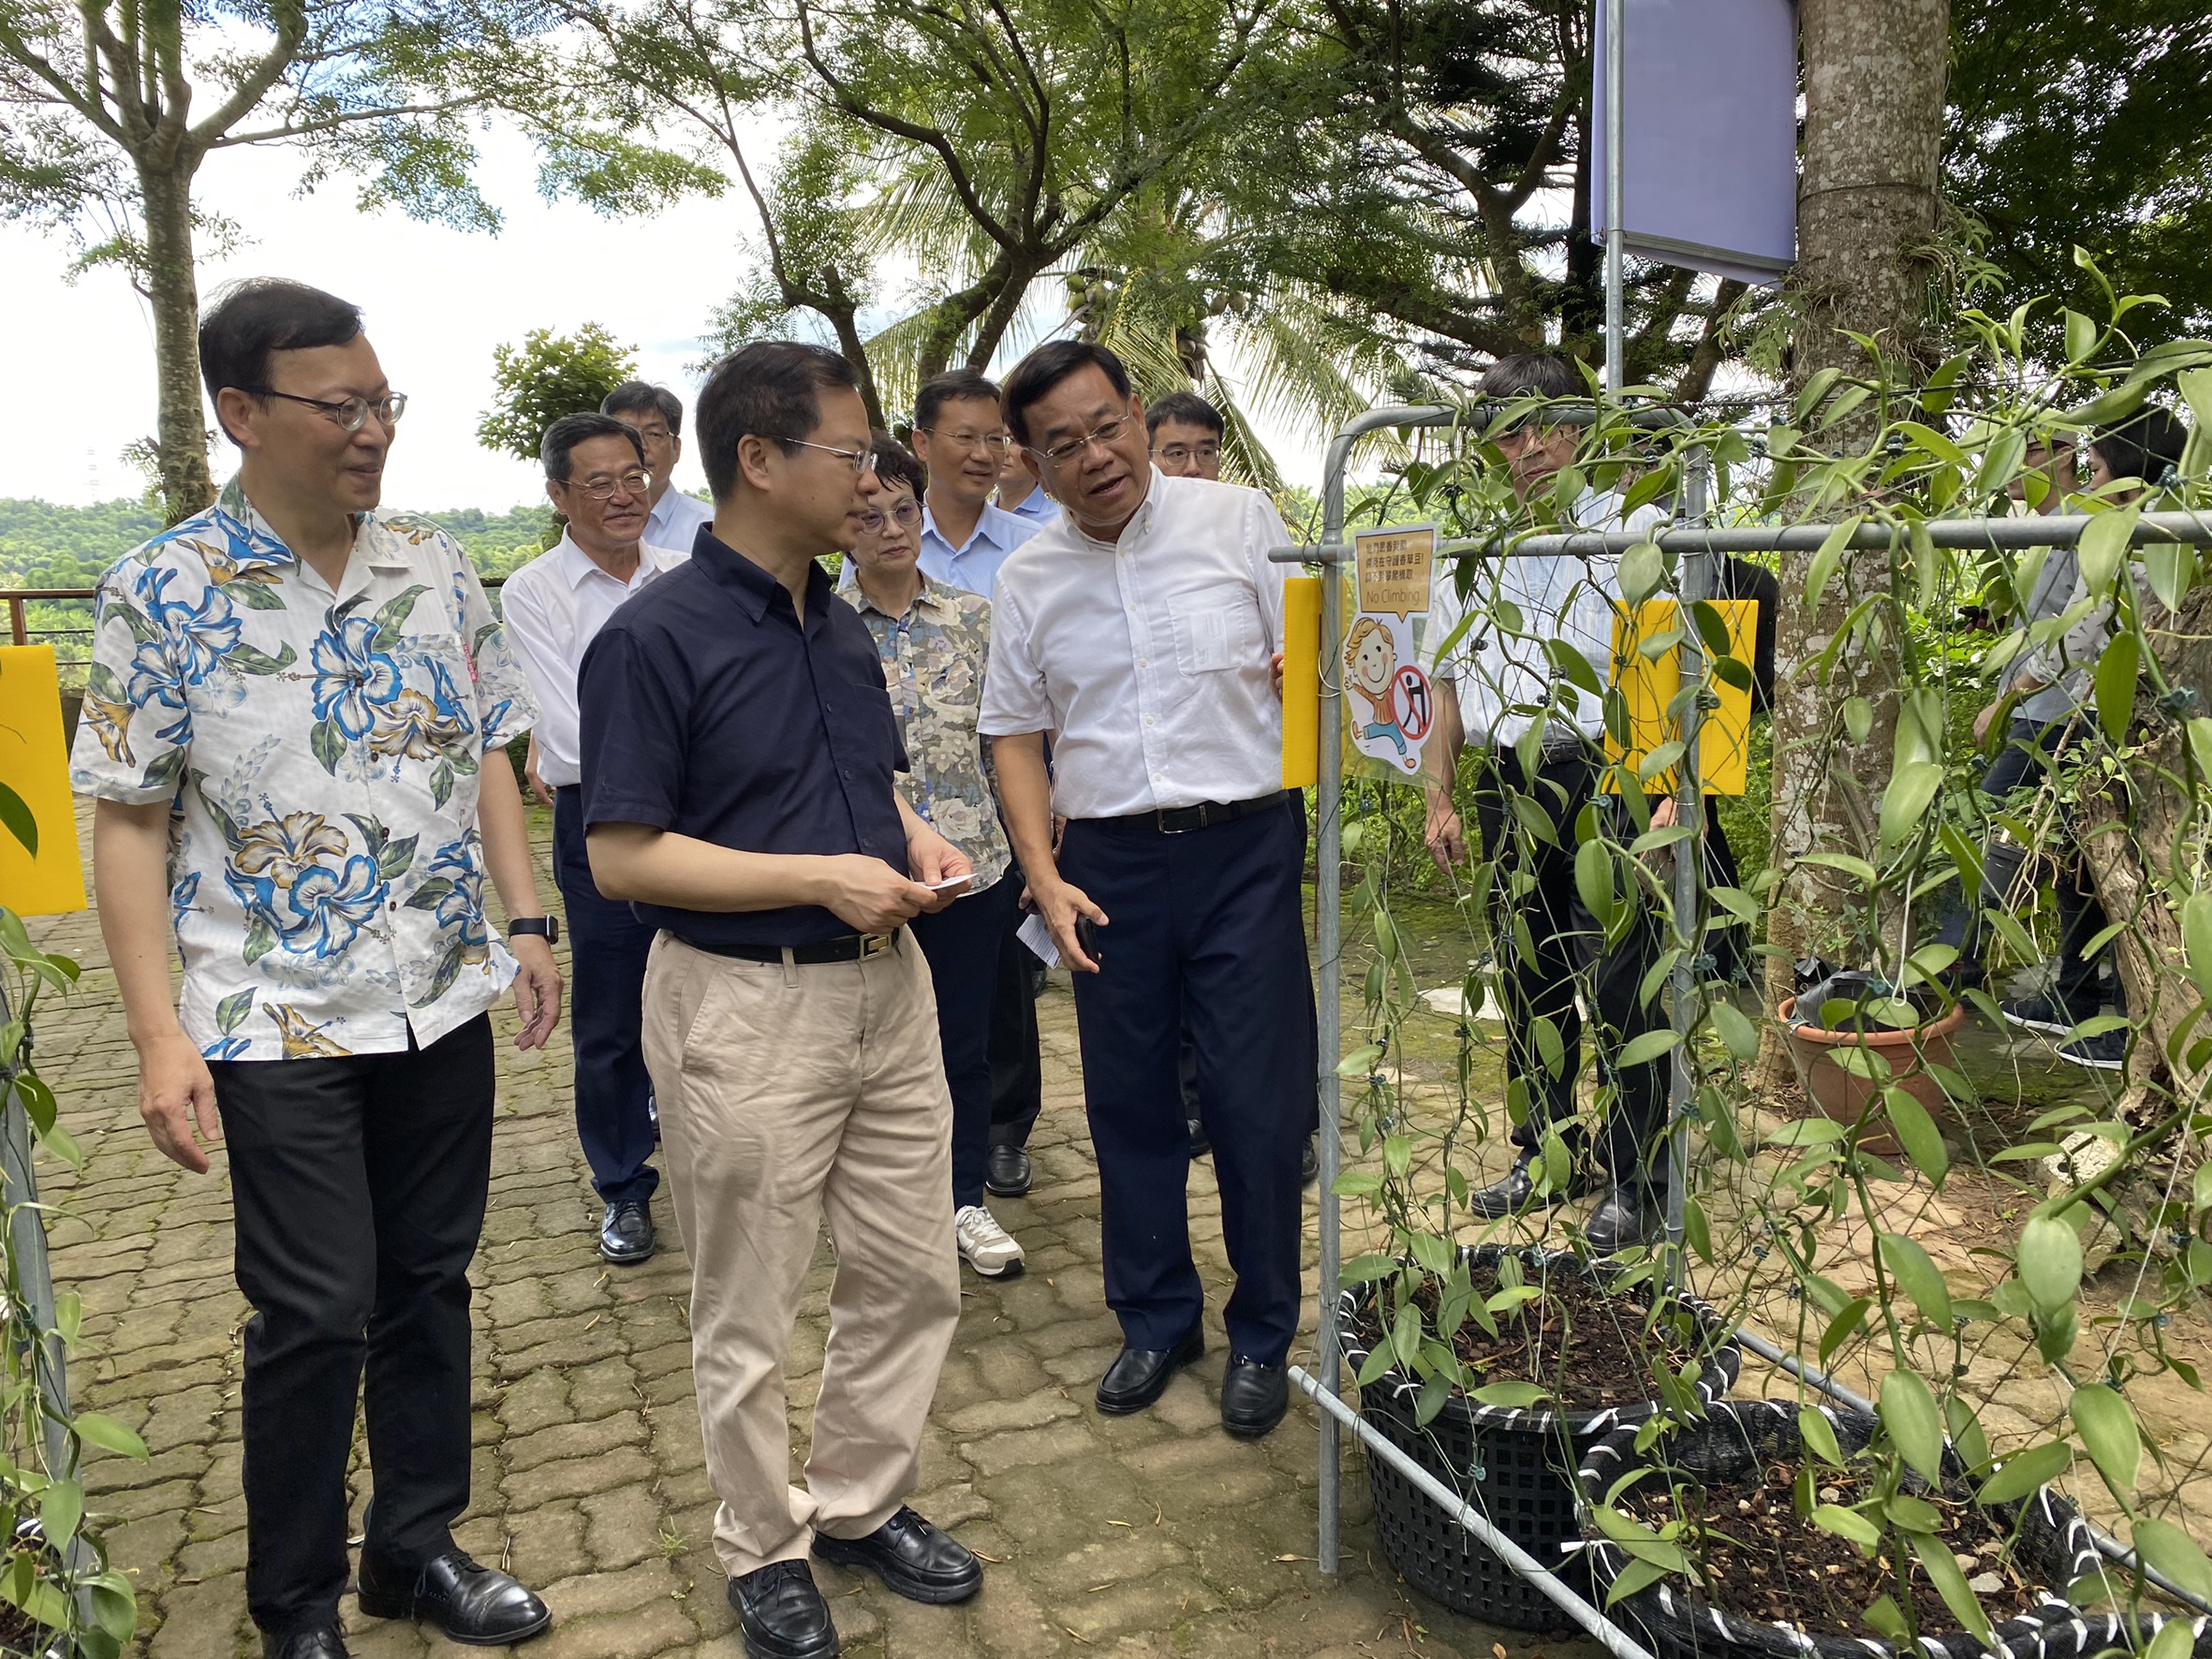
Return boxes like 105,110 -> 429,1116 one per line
1059,807 -> 1314,1365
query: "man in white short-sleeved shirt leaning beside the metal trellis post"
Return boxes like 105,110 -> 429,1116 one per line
980,341 -> 1314,1435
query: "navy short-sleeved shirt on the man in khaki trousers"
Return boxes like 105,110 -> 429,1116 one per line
577,531 -> 907,949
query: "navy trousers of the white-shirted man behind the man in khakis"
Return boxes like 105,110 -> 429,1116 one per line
553,787 -> 661,1203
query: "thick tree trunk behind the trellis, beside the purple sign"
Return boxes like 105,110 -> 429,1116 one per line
1761,0 -> 1951,1086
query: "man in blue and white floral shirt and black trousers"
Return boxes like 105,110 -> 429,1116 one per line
75,279 -> 560,1659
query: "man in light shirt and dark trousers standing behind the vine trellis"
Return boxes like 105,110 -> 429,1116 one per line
1426,352 -> 1666,1252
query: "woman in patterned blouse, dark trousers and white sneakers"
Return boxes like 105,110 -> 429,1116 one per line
841,438 -> 1022,1279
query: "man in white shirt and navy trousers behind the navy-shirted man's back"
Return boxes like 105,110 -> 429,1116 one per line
502,414 -> 690,1268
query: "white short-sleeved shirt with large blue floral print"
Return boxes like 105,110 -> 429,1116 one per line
71,480 -> 536,1060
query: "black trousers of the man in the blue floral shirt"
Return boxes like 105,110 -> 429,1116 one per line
208,1015 -> 494,1635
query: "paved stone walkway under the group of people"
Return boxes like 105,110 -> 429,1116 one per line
33,814 -> 1539,1659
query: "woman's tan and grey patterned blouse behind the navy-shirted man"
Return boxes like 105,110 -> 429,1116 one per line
845,575 -> 1013,894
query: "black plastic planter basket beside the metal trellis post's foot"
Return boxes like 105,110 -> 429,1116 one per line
1336,1245 -> 1743,1630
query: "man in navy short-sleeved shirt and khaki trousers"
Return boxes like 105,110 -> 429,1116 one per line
577,341 -> 982,1659
